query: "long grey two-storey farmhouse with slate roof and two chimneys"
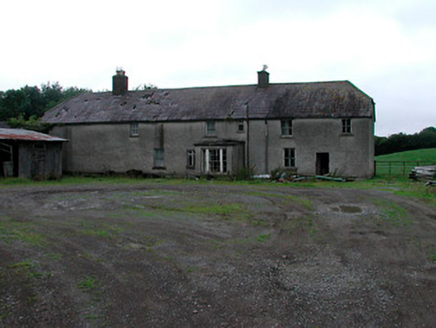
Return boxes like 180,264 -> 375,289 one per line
42,70 -> 375,178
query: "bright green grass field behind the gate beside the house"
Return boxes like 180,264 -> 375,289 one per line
375,148 -> 436,175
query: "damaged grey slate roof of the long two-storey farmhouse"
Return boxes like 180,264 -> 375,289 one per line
42,81 -> 374,124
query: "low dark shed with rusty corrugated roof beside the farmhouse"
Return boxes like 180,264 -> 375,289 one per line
0,128 -> 67,179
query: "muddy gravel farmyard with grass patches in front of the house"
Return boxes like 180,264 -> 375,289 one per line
0,181 -> 436,327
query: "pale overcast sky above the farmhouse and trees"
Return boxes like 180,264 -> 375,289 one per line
0,0 -> 436,136
